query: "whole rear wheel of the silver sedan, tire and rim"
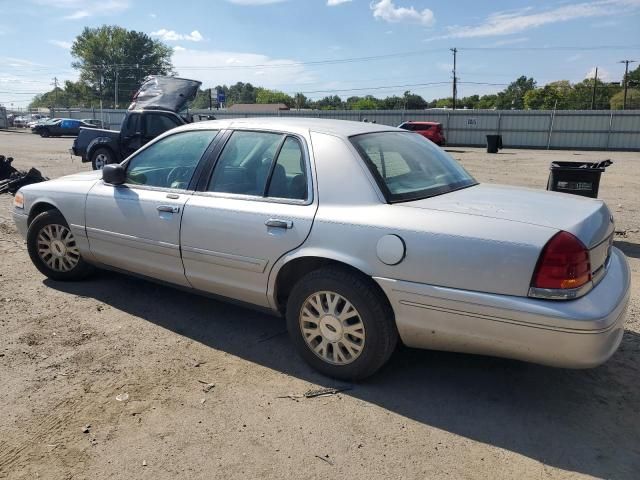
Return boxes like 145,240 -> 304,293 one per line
286,267 -> 398,380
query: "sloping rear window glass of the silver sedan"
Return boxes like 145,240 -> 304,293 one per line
351,132 -> 477,203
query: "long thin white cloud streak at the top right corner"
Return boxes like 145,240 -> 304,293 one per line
441,0 -> 640,38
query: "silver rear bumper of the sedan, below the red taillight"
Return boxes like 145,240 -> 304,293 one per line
375,248 -> 630,368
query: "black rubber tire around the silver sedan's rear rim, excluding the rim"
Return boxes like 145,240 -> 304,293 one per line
286,267 -> 398,381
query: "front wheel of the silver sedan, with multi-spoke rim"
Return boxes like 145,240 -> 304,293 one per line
27,210 -> 93,281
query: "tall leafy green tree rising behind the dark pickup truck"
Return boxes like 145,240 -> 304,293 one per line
71,25 -> 173,107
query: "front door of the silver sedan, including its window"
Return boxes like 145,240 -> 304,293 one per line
86,130 -> 217,286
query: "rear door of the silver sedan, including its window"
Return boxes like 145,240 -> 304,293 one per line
180,130 -> 317,306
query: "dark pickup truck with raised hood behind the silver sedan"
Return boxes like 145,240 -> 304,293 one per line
71,76 -> 201,170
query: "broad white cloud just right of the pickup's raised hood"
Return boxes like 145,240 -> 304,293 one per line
172,48 -> 315,91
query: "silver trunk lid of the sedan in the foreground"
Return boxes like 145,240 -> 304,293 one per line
399,184 -> 614,249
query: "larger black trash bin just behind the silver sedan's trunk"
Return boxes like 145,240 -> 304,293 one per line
547,160 -> 613,198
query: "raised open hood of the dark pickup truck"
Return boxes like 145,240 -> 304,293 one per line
129,75 -> 202,113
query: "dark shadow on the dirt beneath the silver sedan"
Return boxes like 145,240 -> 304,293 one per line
45,272 -> 640,479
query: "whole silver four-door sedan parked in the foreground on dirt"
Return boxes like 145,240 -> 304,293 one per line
13,118 -> 630,380
